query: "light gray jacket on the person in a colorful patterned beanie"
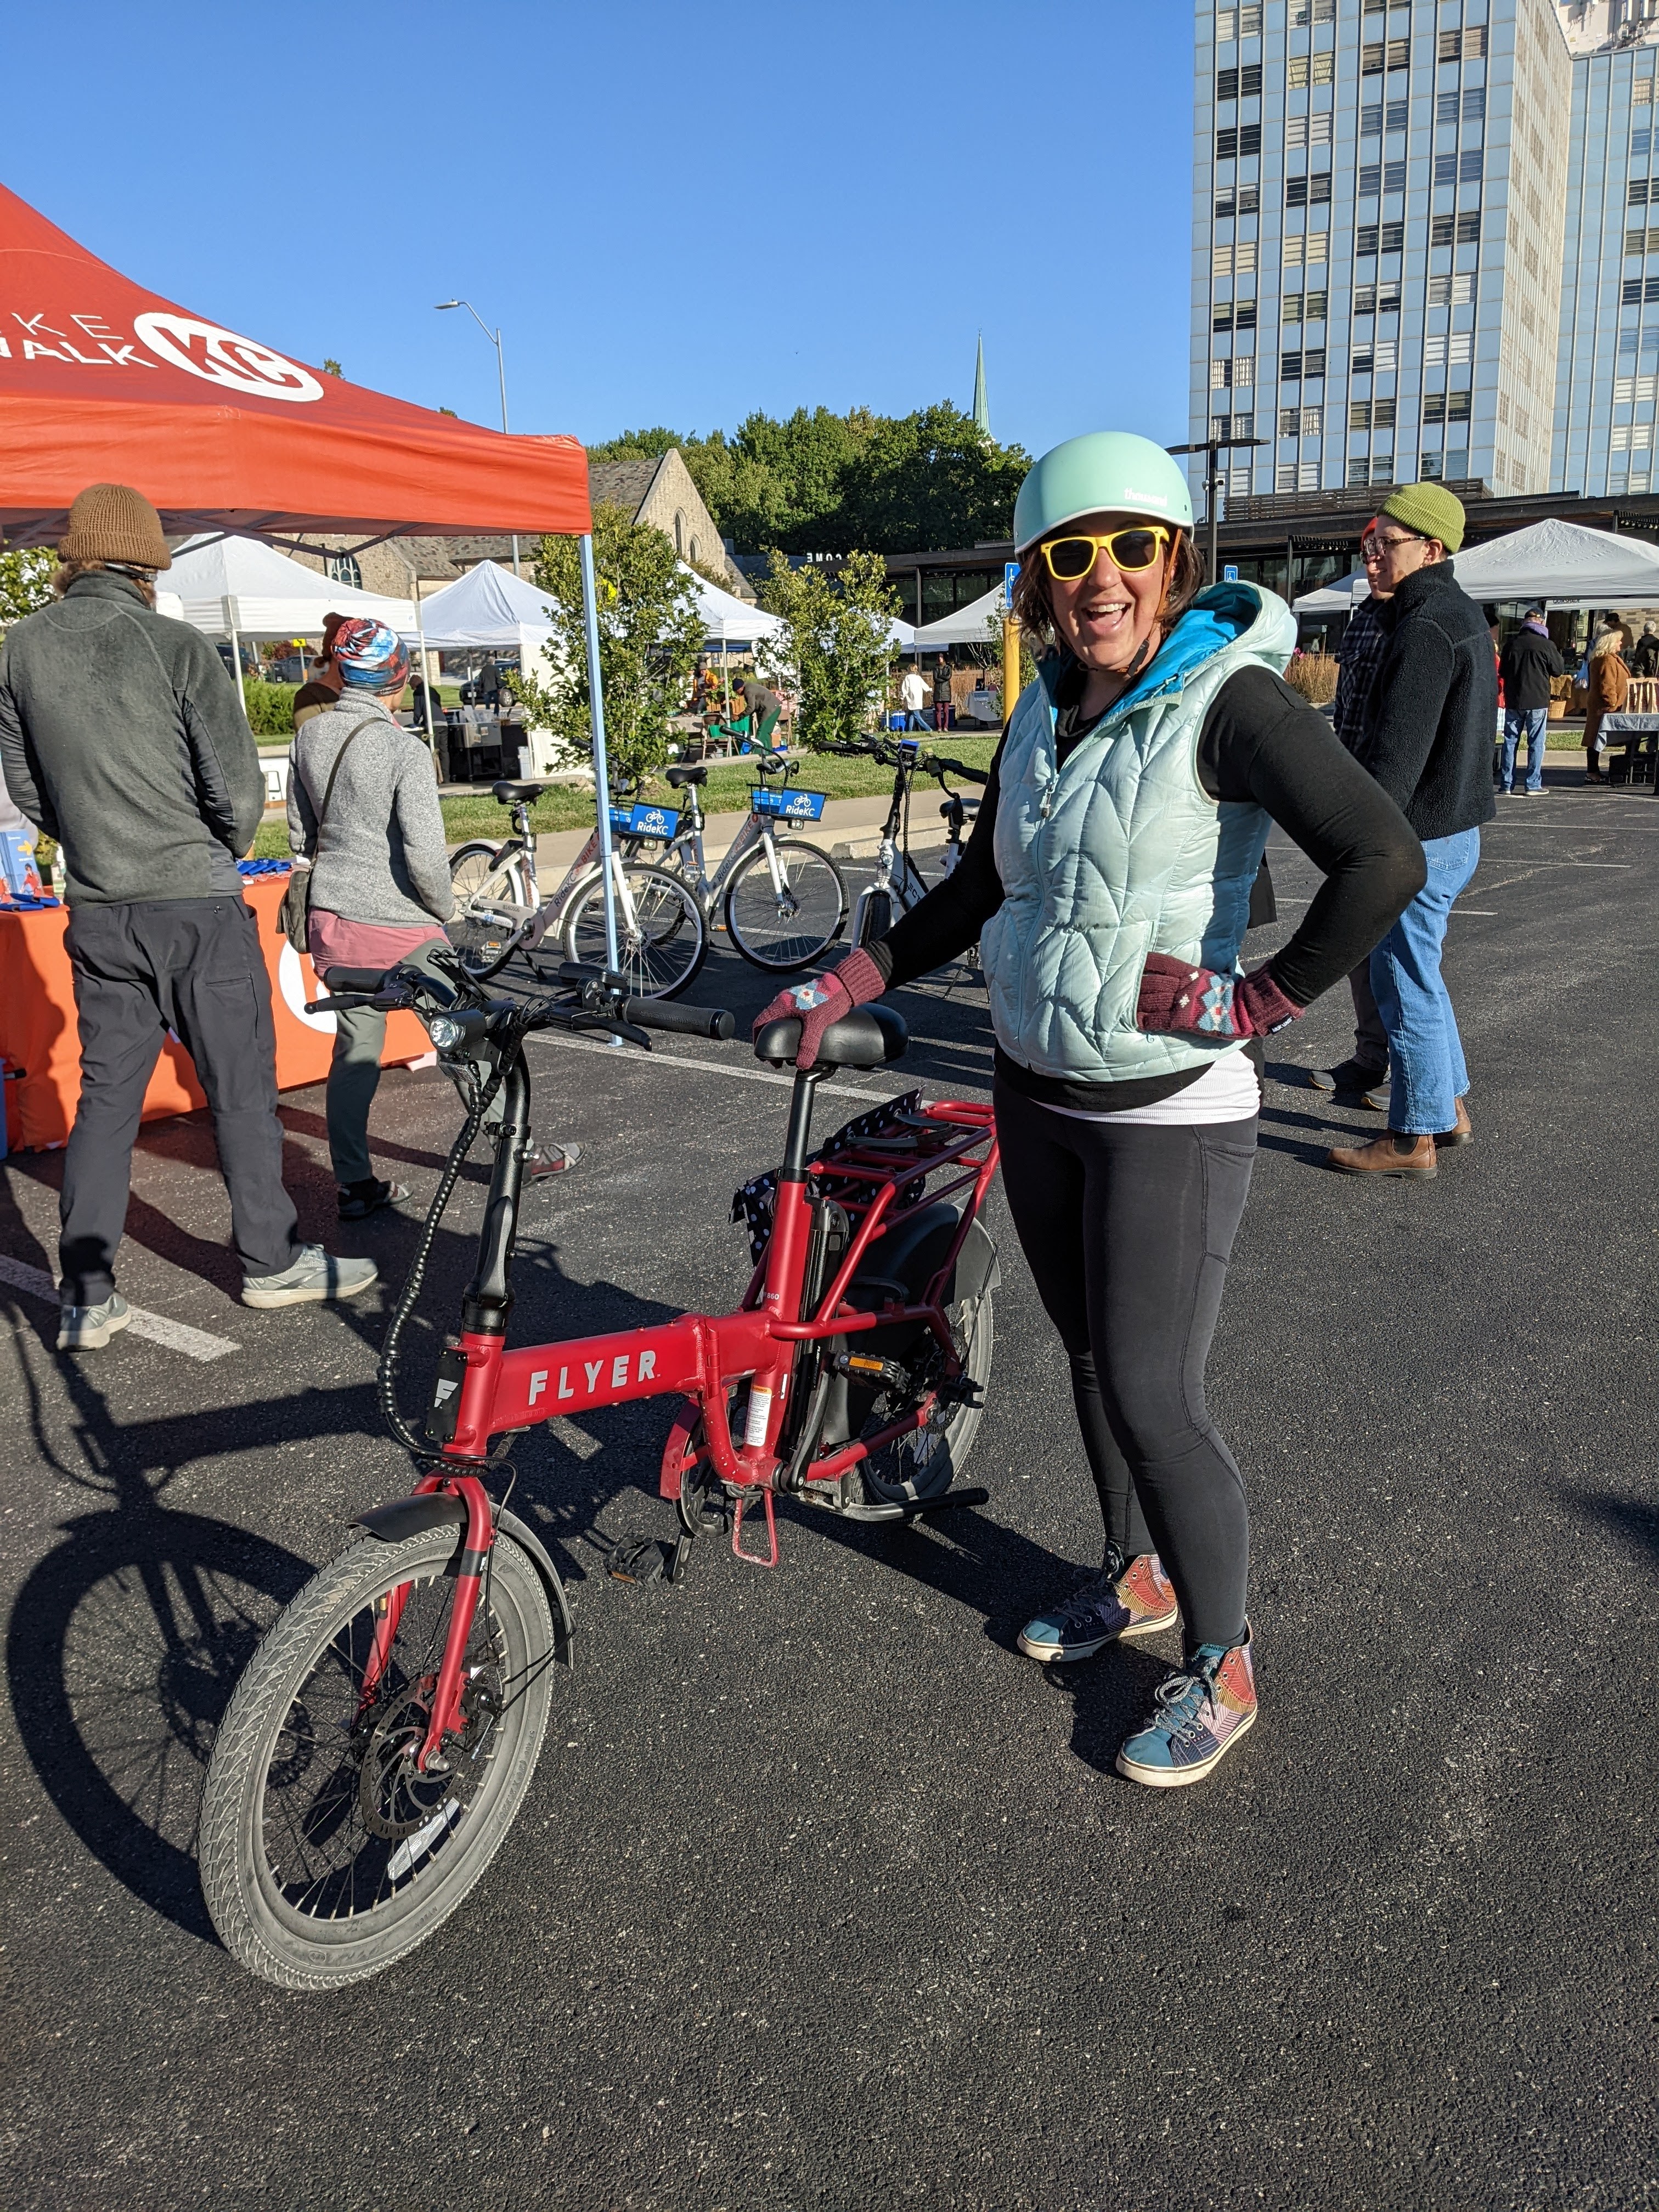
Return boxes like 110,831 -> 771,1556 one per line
287,692 -> 456,929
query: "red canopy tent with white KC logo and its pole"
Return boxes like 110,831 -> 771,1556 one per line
0,186 -> 617,967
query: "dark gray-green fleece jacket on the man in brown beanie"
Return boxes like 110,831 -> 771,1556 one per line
0,571 -> 266,907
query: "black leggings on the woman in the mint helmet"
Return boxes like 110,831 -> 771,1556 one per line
995,1080 -> 1256,1648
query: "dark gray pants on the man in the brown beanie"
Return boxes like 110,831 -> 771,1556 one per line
58,896 -> 298,1305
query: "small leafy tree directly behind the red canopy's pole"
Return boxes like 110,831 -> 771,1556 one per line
515,506 -> 703,776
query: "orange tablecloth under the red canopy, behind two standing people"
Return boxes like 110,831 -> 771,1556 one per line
0,876 -> 431,1150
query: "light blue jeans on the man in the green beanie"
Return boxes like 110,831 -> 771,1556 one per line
1372,830 -> 1480,1137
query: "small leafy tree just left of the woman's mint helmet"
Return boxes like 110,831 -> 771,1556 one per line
757,553 -> 898,748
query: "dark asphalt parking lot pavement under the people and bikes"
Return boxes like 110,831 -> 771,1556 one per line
0,778 -> 1659,2212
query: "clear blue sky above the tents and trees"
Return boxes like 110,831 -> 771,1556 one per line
0,0 -> 1192,452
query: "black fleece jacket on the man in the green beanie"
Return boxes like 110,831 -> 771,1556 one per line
1358,562 -> 1498,843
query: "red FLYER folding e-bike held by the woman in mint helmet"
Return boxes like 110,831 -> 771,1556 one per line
197,967 -> 997,1989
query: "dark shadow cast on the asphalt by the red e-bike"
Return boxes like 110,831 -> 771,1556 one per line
0,1181 -> 690,1942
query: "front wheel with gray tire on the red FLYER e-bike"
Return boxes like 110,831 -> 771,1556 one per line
197,1526 -> 555,1989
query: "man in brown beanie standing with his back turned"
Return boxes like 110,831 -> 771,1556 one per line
0,484 -> 376,1352
